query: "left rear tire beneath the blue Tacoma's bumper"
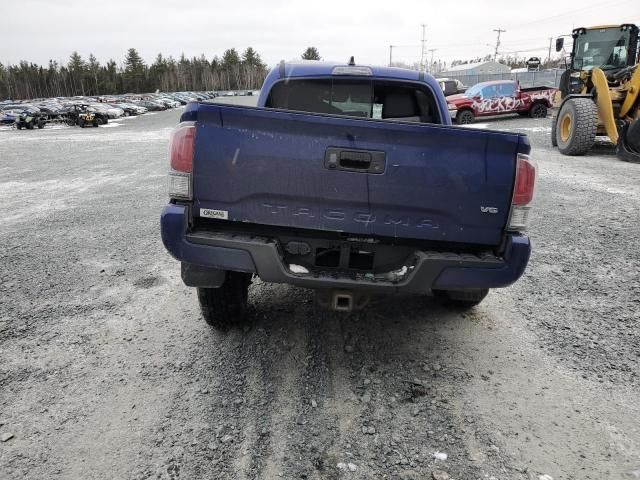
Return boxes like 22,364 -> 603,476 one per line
198,272 -> 251,331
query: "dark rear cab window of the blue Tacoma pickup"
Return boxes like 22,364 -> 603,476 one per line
265,78 -> 442,124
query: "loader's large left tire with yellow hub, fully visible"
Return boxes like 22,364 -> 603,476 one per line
556,98 -> 598,155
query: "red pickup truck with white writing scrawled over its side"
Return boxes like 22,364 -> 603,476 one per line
447,80 -> 558,125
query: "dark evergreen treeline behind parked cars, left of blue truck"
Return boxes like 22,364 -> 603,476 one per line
0,47 -> 267,100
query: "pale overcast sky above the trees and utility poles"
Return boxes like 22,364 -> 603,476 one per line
0,0 -> 640,65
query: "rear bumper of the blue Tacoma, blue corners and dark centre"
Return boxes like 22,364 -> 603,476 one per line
161,205 -> 531,294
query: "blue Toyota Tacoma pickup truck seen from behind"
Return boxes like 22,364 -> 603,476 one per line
161,61 -> 536,328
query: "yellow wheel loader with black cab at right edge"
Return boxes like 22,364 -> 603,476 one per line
551,24 -> 640,162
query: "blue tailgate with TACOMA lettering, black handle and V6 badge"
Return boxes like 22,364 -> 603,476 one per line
193,104 -> 528,245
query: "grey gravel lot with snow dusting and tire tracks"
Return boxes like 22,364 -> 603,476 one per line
0,106 -> 640,480
